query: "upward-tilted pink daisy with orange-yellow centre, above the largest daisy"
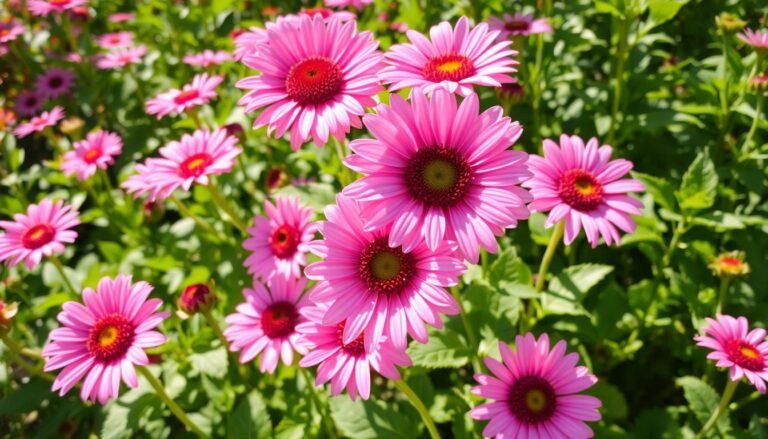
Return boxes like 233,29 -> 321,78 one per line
379,17 -> 517,96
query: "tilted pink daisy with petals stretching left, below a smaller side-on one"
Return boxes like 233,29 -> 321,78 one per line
122,129 -> 242,201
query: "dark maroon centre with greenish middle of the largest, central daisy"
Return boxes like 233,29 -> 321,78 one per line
404,146 -> 472,207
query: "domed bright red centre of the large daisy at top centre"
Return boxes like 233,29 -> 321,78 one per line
285,56 -> 344,105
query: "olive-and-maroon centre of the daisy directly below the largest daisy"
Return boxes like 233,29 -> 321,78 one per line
360,236 -> 416,294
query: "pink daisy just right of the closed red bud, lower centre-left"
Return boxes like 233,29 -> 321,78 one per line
224,276 -> 308,373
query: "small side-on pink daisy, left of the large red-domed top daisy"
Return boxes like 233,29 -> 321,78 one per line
147,73 -> 224,119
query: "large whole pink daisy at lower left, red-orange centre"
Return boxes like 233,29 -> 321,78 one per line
43,274 -> 168,404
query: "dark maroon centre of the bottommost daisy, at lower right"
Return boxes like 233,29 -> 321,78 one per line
508,375 -> 557,424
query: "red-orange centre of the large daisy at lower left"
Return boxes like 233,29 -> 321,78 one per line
87,313 -> 136,362
